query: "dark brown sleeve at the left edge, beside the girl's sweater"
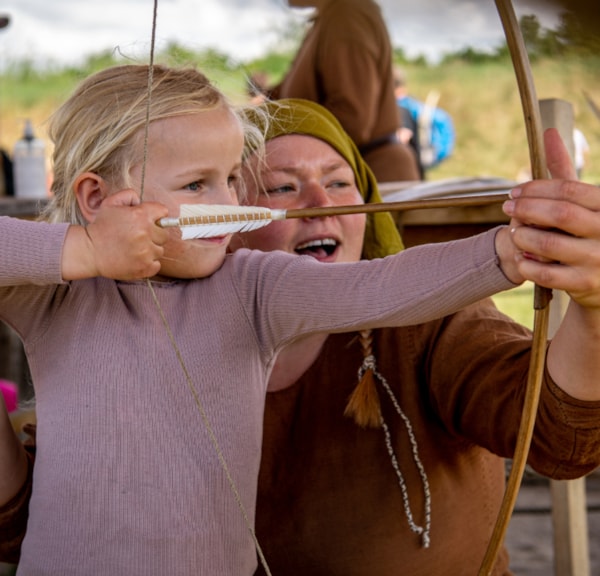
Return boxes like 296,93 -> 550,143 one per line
0,442 -> 35,564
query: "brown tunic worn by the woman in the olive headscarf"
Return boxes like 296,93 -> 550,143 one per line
256,305 -> 600,576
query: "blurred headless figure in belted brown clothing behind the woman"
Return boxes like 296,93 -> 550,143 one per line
268,0 -> 420,182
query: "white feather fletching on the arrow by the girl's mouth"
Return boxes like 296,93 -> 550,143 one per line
159,204 -> 285,240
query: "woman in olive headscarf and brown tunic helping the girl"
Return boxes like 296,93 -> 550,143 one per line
237,101 -> 600,576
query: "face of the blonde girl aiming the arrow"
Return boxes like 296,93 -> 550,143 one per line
132,107 -> 244,278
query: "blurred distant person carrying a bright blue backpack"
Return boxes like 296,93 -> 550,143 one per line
393,66 -> 456,177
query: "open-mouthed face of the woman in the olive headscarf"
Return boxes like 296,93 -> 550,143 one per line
231,134 -> 366,262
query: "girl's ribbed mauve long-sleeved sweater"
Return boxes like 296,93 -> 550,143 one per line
0,217 -> 512,576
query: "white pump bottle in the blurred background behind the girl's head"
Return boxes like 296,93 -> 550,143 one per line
13,120 -> 48,198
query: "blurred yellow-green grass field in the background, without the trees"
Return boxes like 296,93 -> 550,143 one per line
0,52 -> 600,183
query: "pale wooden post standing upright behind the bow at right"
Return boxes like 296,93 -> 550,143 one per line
540,99 -> 590,576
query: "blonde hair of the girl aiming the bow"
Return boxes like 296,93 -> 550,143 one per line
42,64 -> 262,225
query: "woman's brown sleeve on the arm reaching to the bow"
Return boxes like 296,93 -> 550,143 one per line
426,303 -> 600,479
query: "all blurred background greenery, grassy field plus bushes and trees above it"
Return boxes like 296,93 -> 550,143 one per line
0,18 -> 600,187
